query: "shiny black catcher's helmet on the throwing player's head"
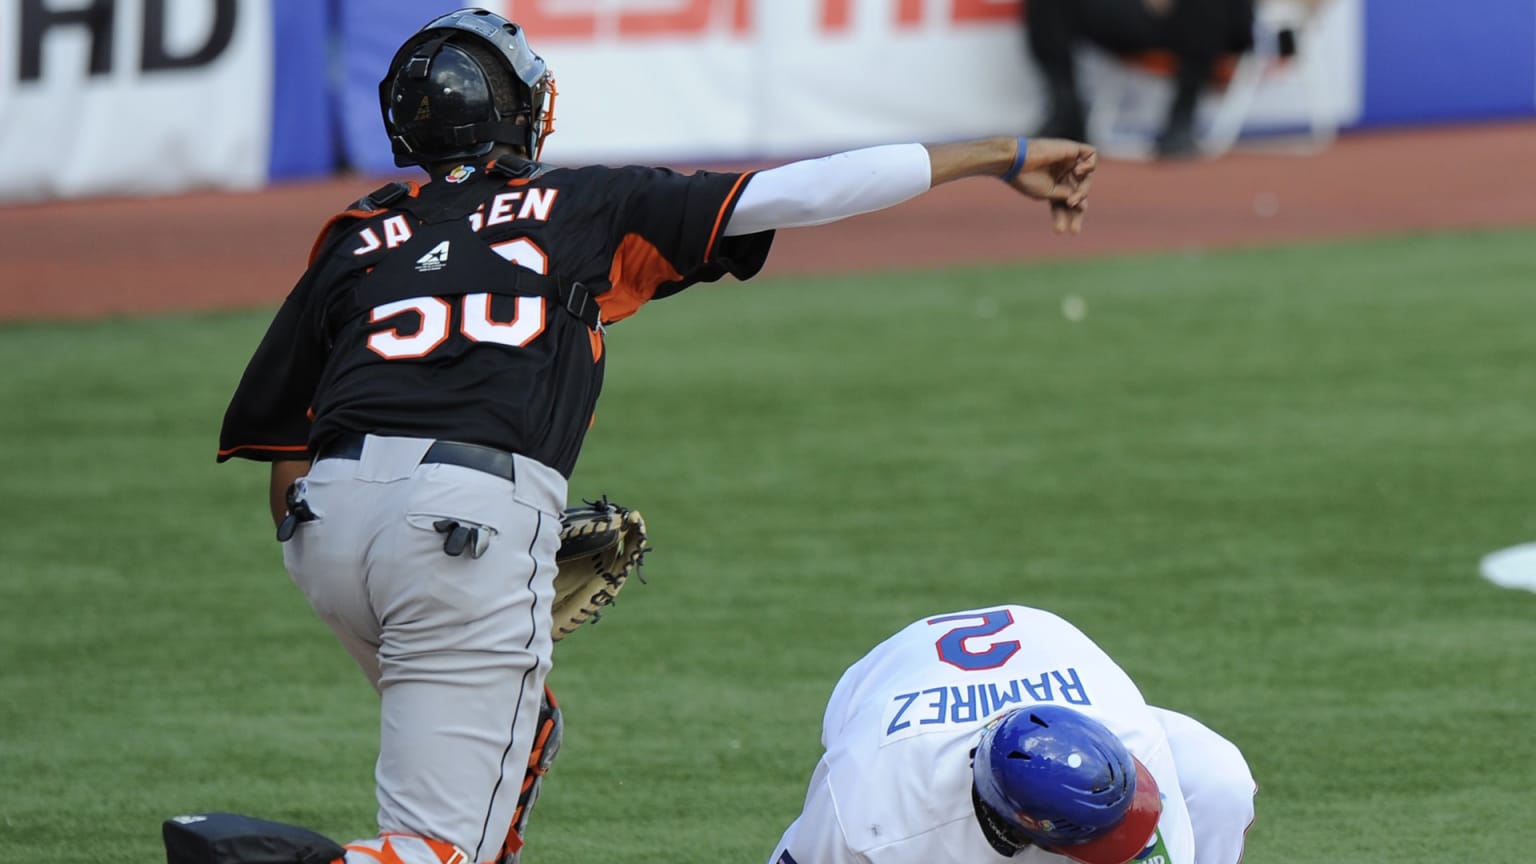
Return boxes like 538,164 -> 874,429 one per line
379,9 -> 556,166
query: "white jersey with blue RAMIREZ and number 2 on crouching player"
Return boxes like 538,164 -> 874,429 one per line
770,606 -> 1197,864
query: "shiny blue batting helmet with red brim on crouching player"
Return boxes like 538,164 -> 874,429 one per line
972,706 -> 1163,864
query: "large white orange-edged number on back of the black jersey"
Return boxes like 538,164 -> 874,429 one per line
369,237 -> 550,360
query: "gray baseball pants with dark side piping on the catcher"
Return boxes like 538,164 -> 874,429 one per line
283,435 -> 567,864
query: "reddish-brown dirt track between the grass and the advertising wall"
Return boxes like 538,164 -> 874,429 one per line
0,123 -> 1536,321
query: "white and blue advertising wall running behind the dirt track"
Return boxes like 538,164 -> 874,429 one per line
0,0 -> 1536,201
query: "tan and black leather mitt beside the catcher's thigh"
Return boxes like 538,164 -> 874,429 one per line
553,495 -> 650,641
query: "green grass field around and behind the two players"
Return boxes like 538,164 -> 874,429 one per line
0,232 -> 1536,864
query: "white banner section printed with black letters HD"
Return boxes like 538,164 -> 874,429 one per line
0,0 -> 272,200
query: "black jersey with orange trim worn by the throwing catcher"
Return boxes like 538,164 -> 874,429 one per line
218,163 -> 773,477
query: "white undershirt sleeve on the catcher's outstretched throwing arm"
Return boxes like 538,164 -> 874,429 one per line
723,145 -> 932,237
